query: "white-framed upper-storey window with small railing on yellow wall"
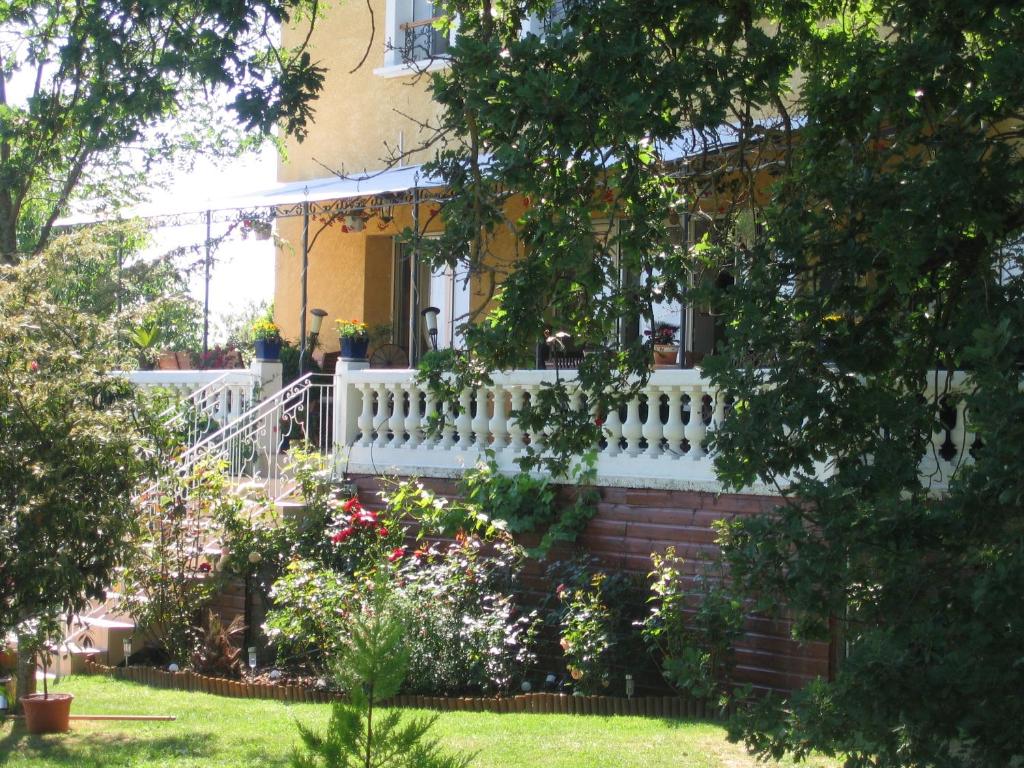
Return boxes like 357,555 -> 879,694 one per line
374,0 -> 451,77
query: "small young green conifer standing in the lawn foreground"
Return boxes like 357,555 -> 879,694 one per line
292,577 -> 469,768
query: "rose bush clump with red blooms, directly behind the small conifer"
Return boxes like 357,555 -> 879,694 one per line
265,471 -> 536,693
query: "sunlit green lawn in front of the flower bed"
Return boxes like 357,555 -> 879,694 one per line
0,677 -> 838,768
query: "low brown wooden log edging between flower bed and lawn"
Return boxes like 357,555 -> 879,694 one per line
84,660 -> 722,720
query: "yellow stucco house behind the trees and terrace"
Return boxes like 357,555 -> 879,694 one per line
274,0 -> 765,366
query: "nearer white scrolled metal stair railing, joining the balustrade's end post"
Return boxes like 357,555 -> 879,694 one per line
174,374 -> 334,500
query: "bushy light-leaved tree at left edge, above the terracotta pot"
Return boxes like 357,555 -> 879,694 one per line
0,238 -> 150,704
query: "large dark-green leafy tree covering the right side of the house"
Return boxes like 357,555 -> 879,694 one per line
423,0 -> 1024,766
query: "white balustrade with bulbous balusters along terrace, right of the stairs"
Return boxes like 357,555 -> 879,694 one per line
333,360 -> 978,493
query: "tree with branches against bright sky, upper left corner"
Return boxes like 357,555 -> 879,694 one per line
0,0 -> 323,263
